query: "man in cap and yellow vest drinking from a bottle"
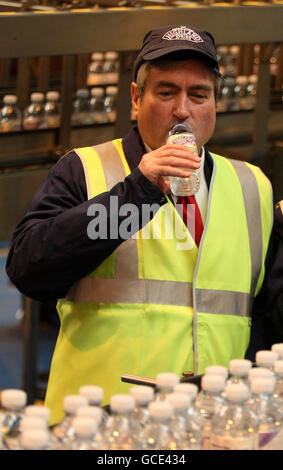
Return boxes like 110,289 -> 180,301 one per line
7,26 -> 272,423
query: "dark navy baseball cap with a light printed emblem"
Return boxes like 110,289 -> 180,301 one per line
134,25 -> 221,81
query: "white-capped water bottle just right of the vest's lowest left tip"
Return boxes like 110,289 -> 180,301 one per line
52,395 -> 88,446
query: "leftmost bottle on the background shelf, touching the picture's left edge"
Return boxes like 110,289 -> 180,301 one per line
0,95 -> 22,132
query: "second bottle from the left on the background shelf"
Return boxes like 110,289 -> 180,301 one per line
23,92 -> 47,130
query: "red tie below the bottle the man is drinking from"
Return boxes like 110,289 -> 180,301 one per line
177,196 -> 203,246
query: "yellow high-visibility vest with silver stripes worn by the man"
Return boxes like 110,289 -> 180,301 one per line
45,139 -> 273,424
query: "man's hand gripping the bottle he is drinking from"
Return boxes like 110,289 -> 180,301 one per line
138,143 -> 201,194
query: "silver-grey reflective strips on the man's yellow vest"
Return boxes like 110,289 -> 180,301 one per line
66,142 -> 261,316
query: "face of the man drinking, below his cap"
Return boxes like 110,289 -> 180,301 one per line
132,59 -> 216,151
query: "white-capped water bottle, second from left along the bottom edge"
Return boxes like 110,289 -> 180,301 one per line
69,417 -> 105,450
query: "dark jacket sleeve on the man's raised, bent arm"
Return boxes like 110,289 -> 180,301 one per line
6,152 -> 164,301
